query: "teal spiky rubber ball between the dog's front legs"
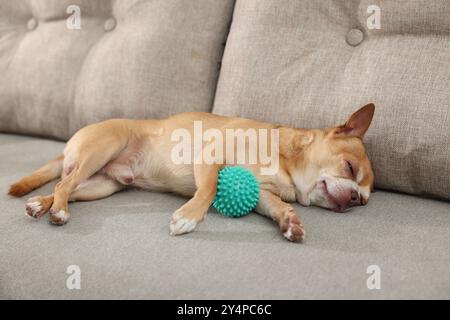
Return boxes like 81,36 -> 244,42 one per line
213,167 -> 259,218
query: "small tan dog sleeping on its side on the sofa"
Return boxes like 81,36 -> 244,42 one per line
9,104 -> 375,241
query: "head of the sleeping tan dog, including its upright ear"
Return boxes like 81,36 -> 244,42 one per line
292,104 -> 375,212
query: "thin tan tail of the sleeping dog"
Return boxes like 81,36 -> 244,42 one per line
8,155 -> 64,197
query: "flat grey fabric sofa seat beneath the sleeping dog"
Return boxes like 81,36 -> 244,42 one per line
0,135 -> 450,299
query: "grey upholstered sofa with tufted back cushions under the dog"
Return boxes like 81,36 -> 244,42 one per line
0,0 -> 450,299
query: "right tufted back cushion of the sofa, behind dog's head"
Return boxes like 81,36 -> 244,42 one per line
213,0 -> 450,199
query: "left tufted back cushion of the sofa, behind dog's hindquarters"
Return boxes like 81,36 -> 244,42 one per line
0,0 -> 233,139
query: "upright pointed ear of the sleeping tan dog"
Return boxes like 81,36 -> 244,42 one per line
334,103 -> 375,139
